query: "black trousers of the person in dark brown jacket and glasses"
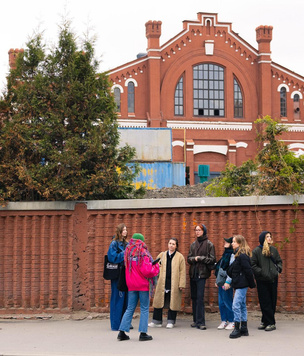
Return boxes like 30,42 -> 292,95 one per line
190,278 -> 206,325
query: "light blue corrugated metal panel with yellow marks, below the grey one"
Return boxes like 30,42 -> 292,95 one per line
135,162 -> 185,189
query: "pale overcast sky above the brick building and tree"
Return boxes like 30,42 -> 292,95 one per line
0,0 -> 304,91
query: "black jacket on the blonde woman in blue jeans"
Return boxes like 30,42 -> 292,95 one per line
227,253 -> 255,289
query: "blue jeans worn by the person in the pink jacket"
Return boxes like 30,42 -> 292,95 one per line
119,291 -> 150,333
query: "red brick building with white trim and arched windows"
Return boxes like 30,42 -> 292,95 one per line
109,13 -> 304,184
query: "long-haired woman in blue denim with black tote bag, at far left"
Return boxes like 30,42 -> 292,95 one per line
108,223 -> 128,331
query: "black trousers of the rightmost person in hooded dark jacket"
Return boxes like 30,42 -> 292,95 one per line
256,278 -> 278,326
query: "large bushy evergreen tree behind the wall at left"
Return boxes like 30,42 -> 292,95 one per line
0,22 -> 143,201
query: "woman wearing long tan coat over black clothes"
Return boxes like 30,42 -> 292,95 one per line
149,237 -> 186,329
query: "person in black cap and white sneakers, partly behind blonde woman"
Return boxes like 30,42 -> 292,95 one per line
215,237 -> 234,330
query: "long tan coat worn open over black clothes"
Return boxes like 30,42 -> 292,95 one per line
153,251 -> 186,310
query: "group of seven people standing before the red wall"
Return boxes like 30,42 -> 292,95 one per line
108,224 -> 282,341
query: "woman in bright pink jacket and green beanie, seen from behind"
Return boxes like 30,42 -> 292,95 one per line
117,233 -> 159,341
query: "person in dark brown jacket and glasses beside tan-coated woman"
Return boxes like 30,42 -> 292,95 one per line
187,224 -> 216,330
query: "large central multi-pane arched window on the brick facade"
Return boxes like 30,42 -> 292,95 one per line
193,63 -> 225,117
